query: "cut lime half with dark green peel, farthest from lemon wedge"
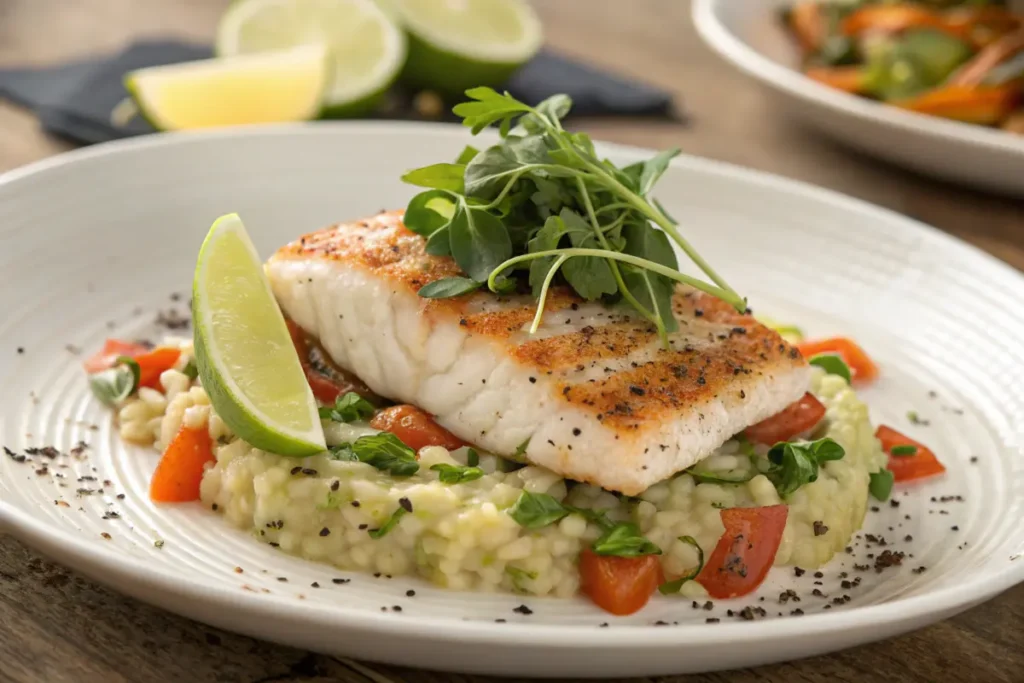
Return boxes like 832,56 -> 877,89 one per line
389,0 -> 543,96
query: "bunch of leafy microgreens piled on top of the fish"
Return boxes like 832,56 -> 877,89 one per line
402,88 -> 746,347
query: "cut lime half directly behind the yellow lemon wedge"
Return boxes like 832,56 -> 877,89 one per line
217,0 -> 406,116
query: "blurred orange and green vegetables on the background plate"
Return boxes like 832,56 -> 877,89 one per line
783,0 -> 1024,134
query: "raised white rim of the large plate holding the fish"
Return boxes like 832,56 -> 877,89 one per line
0,120 -> 1024,650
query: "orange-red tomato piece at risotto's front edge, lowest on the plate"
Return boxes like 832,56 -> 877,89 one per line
580,548 -> 665,616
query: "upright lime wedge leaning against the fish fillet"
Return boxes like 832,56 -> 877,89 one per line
193,213 -> 327,456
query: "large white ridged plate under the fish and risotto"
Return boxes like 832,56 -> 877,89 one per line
0,123 -> 1024,677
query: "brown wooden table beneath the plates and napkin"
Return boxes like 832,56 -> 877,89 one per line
0,0 -> 1024,683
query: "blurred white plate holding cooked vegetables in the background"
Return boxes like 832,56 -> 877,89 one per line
693,0 -> 1024,197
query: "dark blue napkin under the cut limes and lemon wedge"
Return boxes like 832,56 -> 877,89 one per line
0,41 -> 680,144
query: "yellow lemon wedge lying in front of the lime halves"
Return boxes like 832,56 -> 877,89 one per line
125,46 -> 330,130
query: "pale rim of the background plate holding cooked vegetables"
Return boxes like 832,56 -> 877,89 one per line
690,0 -> 1024,159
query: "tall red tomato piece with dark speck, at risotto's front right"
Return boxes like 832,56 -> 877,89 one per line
696,505 -> 790,600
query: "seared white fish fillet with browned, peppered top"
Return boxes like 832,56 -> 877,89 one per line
266,211 -> 810,496
